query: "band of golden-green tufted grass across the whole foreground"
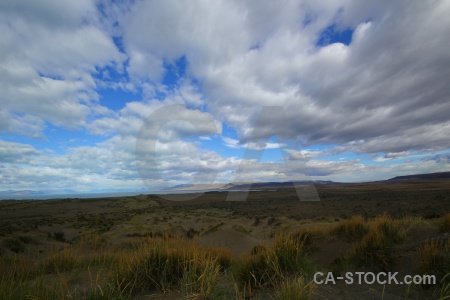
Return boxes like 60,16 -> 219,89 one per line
0,215 -> 450,299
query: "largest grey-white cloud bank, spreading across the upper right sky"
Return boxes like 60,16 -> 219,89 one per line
114,1 -> 450,153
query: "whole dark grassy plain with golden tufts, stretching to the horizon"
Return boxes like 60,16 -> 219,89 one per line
0,180 -> 450,299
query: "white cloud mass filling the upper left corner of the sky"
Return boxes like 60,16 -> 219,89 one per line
0,0 -> 125,136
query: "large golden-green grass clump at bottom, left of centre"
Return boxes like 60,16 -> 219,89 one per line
111,238 -> 231,297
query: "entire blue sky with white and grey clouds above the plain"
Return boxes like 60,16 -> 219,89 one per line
0,0 -> 450,192
